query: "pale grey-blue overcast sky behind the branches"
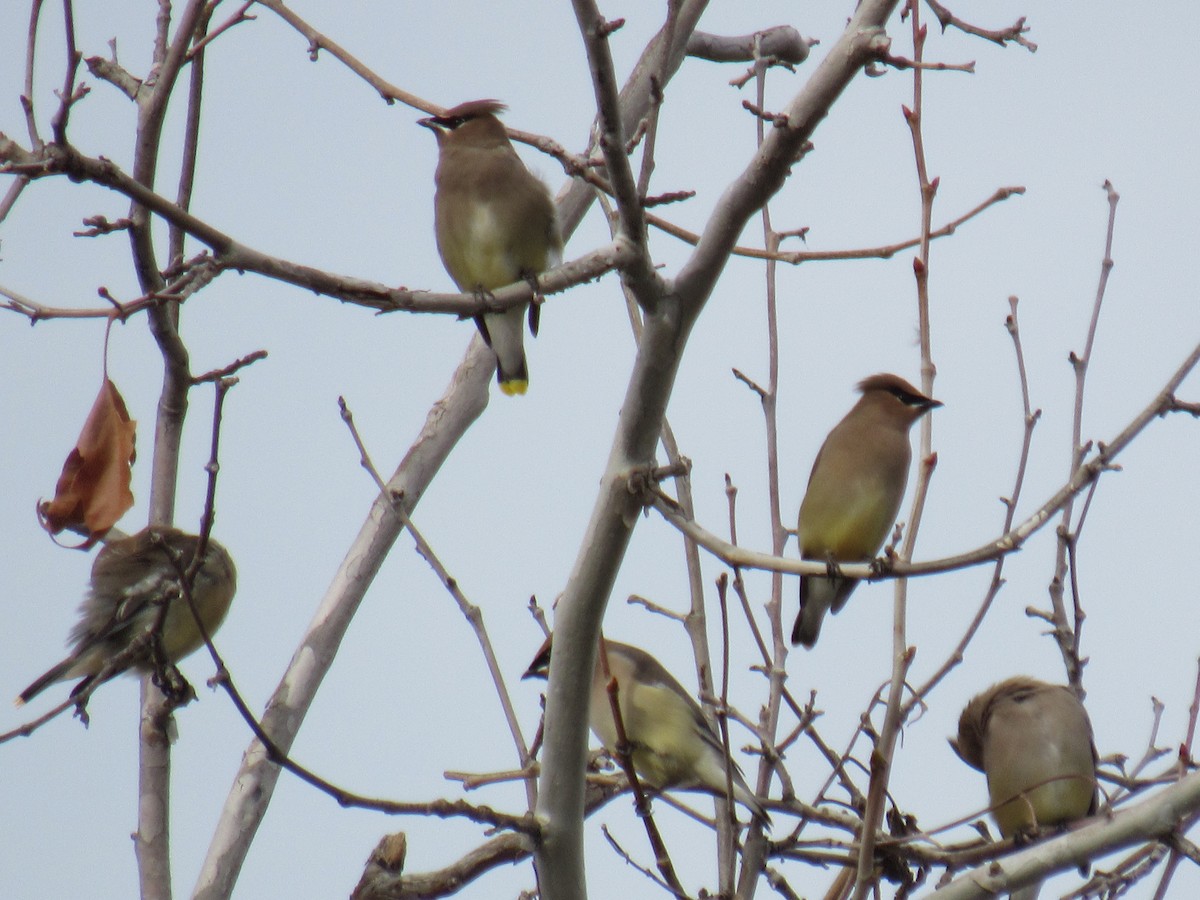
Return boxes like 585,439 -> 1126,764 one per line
0,0 -> 1200,898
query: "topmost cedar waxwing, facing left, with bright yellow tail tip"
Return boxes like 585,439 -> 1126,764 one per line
418,100 -> 563,396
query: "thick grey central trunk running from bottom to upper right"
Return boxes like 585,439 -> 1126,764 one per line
538,7 -> 895,900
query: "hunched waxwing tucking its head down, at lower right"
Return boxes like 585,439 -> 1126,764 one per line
950,676 -> 1097,900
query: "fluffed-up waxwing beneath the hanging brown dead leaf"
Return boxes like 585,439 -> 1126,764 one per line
17,526 -> 238,706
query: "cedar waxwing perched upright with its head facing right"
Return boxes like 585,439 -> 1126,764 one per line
792,374 -> 942,647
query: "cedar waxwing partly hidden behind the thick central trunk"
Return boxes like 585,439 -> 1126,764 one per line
522,637 -> 770,824
